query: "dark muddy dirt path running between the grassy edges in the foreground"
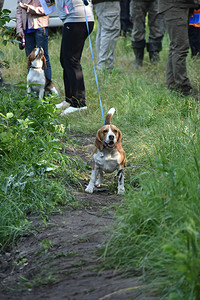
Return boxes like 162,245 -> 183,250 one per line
0,135 -> 156,300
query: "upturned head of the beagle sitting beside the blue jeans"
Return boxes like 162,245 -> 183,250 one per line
27,47 -> 47,69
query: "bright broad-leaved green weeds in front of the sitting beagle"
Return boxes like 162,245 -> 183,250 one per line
0,90 -> 59,154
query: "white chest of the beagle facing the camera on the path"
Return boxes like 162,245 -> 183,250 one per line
93,148 -> 121,173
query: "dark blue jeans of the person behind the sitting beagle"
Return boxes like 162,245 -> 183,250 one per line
25,27 -> 51,80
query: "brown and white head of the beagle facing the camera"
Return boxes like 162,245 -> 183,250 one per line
95,125 -> 122,151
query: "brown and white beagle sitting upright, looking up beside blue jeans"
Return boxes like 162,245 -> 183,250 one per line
27,47 -> 58,99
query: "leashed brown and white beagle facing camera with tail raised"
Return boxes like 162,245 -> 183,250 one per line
85,108 -> 126,194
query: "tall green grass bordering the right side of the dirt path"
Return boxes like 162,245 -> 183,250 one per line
104,123 -> 200,299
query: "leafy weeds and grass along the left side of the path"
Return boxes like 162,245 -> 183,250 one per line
0,89 -> 85,248
